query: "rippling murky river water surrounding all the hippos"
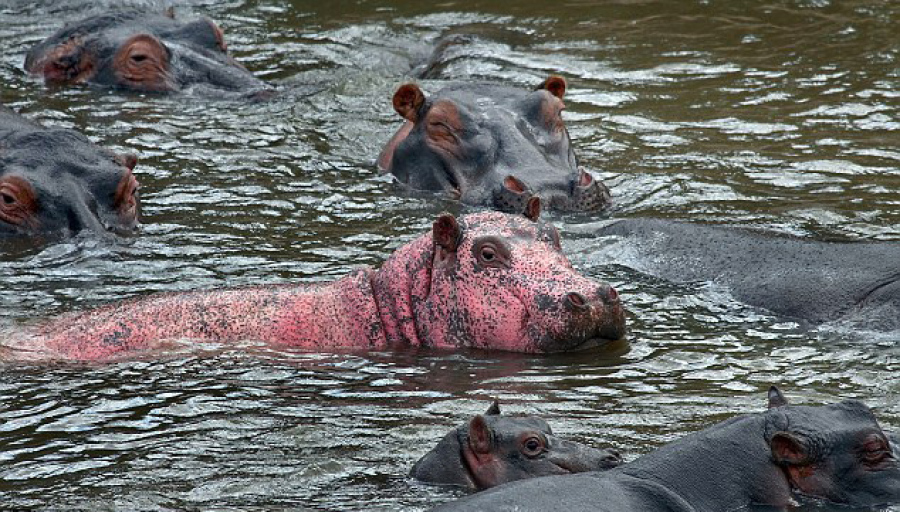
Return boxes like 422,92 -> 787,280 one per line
0,0 -> 900,510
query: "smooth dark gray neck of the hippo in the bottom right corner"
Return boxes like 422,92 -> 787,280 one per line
621,414 -> 791,511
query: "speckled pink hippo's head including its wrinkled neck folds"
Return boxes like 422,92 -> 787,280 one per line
375,198 -> 625,352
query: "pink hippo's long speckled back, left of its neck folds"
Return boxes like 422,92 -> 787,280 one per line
25,268 -> 384,360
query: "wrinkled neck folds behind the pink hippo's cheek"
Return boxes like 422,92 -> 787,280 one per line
372,235 -> 434,346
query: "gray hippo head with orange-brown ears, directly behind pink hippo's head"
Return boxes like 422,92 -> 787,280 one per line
378,76 -> 610,212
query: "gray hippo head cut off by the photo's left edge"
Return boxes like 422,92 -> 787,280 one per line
0,106 -> 139,239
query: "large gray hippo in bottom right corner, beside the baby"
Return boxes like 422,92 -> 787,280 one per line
435,387 -> 900,512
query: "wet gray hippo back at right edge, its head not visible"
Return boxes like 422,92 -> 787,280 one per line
596,219 -> 900,330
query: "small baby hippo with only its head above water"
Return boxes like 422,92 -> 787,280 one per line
410,401 -> 622,491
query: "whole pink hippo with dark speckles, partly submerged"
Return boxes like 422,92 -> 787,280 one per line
8,204 -> 625,360
